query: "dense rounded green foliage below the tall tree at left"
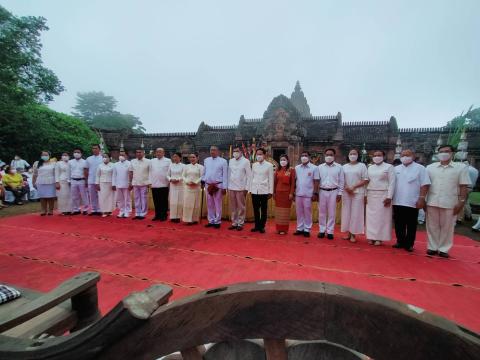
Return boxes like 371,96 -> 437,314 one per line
0,104 -> 99,161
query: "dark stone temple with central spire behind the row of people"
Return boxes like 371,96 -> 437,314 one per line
101,81 -> 480,167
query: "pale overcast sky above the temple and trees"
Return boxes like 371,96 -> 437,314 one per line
4,0 -> 480,132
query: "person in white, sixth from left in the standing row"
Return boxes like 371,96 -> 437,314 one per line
112,151 -> 132,218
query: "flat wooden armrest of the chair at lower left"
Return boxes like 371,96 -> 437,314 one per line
0,272 -> 100,333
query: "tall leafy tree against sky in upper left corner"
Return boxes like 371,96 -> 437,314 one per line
0,6 -> 64,107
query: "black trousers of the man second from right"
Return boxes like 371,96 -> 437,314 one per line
393,205 -> 418,248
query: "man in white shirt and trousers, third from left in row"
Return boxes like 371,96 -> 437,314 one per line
68,149 -> 89,215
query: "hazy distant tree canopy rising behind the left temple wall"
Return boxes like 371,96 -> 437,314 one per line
73,91 -> 145,133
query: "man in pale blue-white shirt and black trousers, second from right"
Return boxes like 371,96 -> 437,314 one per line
393,149 -> 430,252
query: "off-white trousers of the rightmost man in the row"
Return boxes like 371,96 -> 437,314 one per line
427,206 -> 457,253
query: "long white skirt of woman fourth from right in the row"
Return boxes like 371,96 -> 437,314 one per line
341,192 -> 365,235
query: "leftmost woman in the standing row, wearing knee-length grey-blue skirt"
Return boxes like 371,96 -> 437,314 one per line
32,150 -> 57,216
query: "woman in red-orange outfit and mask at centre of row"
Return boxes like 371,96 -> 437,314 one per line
273,154 -> 295,235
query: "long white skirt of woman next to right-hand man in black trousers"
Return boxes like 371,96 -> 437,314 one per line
367,190 -> 392,241
